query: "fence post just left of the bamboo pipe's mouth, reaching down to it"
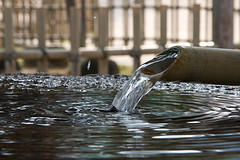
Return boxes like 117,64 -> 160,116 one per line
133,5 -> 142,71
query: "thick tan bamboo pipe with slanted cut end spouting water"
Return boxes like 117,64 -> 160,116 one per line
140,46 -> 240,85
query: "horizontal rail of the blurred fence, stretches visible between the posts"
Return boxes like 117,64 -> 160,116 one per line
0,47 -> 164,60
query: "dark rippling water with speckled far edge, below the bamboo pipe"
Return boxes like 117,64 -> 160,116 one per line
0,74 -> 240,160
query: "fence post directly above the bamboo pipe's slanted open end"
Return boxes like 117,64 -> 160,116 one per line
160,5 -> 167,48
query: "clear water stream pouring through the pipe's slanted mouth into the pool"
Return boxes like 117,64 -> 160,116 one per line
112,47 -> 179,113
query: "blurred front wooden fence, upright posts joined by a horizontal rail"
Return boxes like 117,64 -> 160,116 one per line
0,1 -> 225,75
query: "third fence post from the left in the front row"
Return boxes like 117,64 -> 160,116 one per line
70,7 -> 81,76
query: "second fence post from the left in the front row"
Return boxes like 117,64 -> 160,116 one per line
37,8 -> 48,72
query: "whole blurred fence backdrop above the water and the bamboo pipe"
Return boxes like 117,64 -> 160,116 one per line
0,0 -> 237,75
